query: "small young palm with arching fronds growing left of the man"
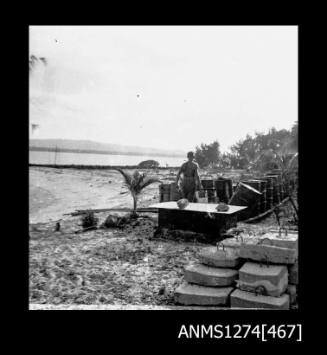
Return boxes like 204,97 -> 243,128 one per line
116,169 -> 160,217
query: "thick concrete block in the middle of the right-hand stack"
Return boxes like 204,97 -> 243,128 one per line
237,262 -> 288,297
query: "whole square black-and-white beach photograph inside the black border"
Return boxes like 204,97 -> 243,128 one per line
27,25 -> 302,313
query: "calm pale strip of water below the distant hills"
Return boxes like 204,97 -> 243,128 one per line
29,150 -> 185,166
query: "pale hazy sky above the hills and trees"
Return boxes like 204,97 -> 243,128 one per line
30,26 -> 298,151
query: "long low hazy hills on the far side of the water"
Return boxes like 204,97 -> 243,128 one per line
29,147 -> 185,158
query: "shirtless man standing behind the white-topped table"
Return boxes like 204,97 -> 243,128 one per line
176,152 -> 202,202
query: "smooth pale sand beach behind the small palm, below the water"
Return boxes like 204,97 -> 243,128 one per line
29,167 -> 168,223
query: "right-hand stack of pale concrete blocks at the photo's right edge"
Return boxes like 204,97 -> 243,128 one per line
223,232 -> 298,309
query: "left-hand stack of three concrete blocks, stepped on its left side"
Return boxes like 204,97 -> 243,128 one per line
175,247 -> 241,306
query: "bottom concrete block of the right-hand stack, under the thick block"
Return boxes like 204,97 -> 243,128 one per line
230,290 -> 290,309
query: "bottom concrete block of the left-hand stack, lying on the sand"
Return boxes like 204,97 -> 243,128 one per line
174,282 -> 234,306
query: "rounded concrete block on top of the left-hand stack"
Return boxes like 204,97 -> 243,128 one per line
199,247 -> 241,268
